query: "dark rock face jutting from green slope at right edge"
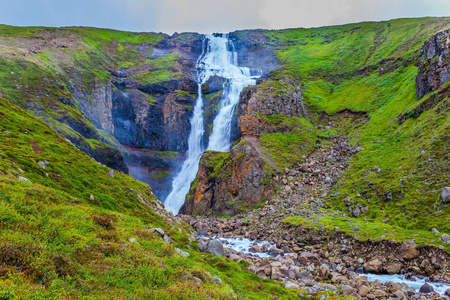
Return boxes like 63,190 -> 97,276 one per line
416,30 -> 450,99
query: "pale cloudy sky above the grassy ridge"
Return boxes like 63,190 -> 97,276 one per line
0,0 -> 450,34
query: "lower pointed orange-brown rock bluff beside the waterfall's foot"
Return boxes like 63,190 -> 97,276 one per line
180,138 -> 273,215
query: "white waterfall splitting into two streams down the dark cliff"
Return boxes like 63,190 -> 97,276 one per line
164,35 -> 261,214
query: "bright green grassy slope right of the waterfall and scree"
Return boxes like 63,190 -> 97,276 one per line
236,18 -> 450,232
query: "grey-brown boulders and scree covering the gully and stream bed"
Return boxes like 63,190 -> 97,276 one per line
179,137 -> 450,299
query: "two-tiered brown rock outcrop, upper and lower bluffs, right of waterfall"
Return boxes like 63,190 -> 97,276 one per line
180,81 -> 312,215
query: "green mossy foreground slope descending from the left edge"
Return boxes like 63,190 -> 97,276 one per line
0,98 -> 304,299
